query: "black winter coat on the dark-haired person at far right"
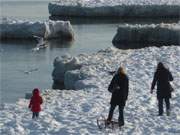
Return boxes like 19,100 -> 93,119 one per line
151,68 -> 173,99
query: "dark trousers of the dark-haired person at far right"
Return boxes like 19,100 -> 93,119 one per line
158,98 -> 170,115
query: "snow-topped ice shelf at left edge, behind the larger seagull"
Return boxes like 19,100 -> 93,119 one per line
0,18 -> 74,39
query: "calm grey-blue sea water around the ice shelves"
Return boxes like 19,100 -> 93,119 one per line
0,0 -> 178,103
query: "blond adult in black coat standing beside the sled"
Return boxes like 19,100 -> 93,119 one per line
107,67 -> 129,126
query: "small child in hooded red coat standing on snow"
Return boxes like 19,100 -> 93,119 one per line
29,88 -> 43,119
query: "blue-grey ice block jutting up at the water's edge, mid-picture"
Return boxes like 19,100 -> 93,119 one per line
52,55 -> 82,89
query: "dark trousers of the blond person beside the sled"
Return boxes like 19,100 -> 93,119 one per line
107,105 -> 124,126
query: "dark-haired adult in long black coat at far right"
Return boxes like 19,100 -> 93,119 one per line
151,62 -> 173,116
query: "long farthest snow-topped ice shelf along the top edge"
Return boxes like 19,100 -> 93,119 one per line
48,0 -> 180,18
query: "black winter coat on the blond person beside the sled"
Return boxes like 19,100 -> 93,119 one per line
108,74 -> 129,106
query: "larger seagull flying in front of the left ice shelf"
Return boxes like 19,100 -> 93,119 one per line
32,35 -> 47,51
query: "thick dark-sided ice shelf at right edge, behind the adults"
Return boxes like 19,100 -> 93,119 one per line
112,23 -> 180,48
